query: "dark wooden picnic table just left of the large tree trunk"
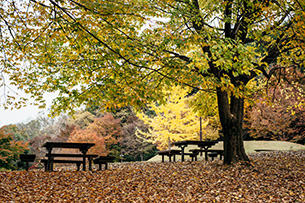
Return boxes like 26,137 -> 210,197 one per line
172,140 -> 218,161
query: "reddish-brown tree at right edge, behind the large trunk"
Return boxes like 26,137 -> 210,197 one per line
245,68 -> 305,142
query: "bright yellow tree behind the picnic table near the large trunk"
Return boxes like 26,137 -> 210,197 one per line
137,86 -> 218,149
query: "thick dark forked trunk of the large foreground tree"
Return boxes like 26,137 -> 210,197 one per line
217,88 -> 250,165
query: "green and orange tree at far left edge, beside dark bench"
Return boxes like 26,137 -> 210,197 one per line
0,126 -> 28,170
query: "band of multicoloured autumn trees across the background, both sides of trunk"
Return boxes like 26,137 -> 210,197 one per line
0,68 -> 305,170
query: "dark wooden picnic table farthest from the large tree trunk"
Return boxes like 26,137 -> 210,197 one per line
42,142 -> 97,171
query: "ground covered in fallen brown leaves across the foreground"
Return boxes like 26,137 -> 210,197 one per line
0,151 -> 305,203
